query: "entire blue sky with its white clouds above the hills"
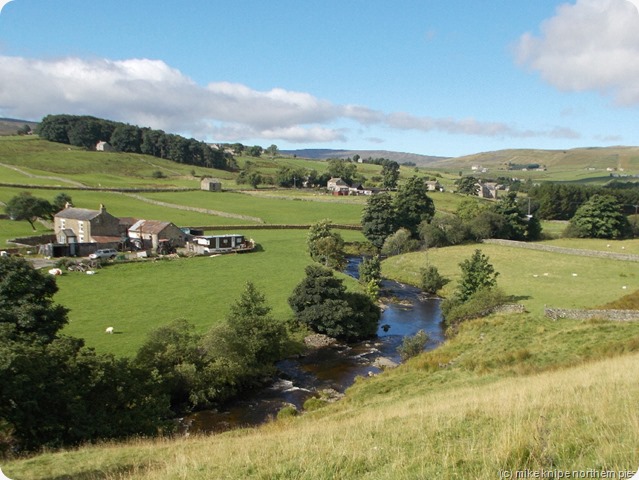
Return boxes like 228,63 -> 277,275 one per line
0,0 -> 639,156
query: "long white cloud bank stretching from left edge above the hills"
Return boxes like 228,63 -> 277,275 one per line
0,56 -> 576,143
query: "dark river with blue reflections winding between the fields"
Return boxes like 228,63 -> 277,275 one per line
182,257 -> 444,433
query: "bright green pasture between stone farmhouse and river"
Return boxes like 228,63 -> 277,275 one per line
54,230 -> 363,355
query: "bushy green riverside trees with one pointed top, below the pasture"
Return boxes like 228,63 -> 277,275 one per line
135,282 -> 288,413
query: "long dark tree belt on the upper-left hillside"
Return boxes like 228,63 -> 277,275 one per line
37,115 -> 237,170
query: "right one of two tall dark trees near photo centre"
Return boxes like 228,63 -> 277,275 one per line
393,176 -> 435,237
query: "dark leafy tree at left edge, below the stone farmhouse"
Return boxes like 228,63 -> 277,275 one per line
0,257 -> 68,341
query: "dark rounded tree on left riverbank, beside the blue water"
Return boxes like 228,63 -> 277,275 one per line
288,265 -> 380,341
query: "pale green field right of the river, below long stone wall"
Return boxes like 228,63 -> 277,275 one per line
382,240 -> 639,313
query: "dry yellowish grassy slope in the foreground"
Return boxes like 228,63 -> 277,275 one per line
3,315 -> 639,480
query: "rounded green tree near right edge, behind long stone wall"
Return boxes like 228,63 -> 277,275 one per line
568,195 -> 631,238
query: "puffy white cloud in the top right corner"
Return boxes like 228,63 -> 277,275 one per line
515,0 -> 639,106
